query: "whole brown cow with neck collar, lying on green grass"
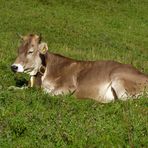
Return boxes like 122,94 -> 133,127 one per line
11,34 -> 148,103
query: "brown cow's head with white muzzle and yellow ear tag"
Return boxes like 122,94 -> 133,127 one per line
11,34 -> 48,75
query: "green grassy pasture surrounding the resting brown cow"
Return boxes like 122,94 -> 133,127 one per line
0,0 -> 148,148
